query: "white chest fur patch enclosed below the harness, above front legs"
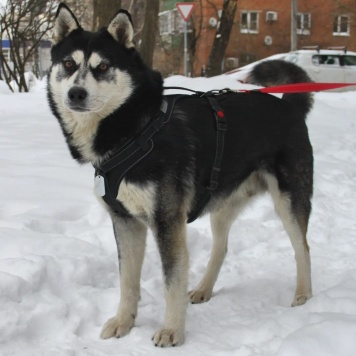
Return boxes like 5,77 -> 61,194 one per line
117,179 -> 156,218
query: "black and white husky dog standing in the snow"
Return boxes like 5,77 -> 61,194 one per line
48,4 -> 313,347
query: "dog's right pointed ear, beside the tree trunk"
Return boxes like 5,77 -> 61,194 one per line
108,10 -> 135,48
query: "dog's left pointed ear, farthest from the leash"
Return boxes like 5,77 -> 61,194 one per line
52,3 -> 81,44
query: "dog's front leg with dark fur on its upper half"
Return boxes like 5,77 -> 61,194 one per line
152,216 -> 189,347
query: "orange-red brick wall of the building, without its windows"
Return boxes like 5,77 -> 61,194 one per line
188,0 -> 356,75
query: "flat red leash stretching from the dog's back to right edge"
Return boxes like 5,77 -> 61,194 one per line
239,83 -> 356,94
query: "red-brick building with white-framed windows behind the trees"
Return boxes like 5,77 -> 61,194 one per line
161,0 -> 356,76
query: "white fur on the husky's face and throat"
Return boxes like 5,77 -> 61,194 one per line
49,50 -> 133,163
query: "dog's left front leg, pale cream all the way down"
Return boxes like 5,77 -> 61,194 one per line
100,216 -> 147,339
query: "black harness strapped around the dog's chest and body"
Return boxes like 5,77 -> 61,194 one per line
94,87 -> 228,223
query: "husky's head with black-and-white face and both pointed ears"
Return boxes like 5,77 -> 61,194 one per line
48,4 -> 140,121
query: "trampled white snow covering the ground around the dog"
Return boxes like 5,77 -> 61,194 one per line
0,76 -> 356,356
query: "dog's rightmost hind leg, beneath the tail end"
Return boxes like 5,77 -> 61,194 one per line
266,174 -> 312,306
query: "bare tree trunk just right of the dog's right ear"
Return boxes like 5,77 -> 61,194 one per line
139,0 -> 159,67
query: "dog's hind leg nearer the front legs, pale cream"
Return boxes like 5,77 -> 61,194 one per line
189,197 -> 249,304
